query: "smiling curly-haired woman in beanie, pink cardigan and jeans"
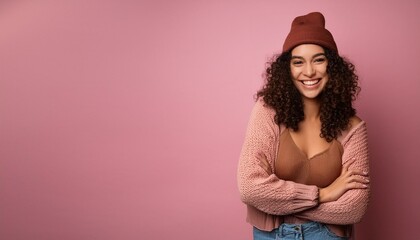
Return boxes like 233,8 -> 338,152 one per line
238,12 -> 369,240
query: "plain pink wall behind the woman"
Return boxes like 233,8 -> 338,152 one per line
0,0 -> 420,240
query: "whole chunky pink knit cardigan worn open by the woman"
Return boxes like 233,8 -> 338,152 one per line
237,99 -> 370,231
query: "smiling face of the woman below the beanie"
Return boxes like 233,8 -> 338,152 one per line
290,44 -> 328,99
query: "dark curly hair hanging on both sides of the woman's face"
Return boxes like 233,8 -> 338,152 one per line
256,48 -> 360,142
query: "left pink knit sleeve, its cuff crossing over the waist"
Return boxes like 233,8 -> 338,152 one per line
237,100 -> 318,215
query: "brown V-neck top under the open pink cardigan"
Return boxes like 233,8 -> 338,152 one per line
275,129 -> 344,187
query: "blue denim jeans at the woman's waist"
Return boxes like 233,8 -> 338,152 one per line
253,222 -> 348,240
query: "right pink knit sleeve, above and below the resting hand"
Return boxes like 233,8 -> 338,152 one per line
297,122 -> 370,225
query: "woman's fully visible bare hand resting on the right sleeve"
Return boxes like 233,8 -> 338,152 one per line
319,159 -> 369,203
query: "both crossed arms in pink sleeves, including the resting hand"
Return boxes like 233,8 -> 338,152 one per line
238,99 -> 369,224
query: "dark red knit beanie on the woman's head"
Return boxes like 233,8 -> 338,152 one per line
283,12 -> 338,52
